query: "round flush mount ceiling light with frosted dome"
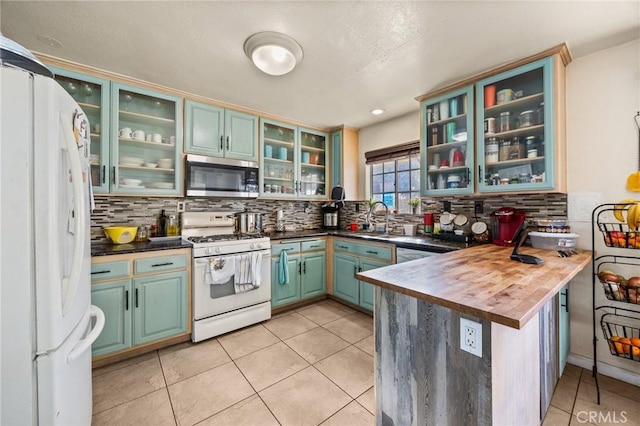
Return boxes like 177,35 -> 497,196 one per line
244,31 -> 302,75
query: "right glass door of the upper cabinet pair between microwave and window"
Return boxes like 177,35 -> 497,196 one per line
298,128 -> 329,198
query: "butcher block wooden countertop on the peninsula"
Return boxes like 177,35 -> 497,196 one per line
357,244 -> 591,329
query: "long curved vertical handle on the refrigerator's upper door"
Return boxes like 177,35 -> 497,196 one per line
60,113 -> 87,315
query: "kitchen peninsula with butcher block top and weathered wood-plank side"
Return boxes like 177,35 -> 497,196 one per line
357,245 -> 591,425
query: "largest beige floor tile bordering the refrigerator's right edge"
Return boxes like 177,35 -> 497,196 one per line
93,356 -> 167,414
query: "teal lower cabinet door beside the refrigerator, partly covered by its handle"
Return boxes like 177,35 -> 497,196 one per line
91,279 -> 133,356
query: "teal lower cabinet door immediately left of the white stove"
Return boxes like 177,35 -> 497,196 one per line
133,272 -> 187,345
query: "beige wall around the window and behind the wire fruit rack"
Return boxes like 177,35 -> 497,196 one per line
359,40 -> 640,384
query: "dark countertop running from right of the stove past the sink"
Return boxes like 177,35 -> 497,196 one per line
267,229 -> 469,253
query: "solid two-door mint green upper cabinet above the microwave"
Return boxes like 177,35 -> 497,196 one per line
185,100 -> 258,161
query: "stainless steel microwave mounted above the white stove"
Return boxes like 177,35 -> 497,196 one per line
185,155 -> 258,198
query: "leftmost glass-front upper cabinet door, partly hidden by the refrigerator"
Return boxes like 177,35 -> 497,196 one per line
50,67 -> 110,193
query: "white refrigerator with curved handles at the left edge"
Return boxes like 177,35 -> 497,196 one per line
0,50 -> 104,426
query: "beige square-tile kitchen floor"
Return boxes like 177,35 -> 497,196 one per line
93,300 -> 640,426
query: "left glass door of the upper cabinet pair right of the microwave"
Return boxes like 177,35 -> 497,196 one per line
260,119 -> 298,198
